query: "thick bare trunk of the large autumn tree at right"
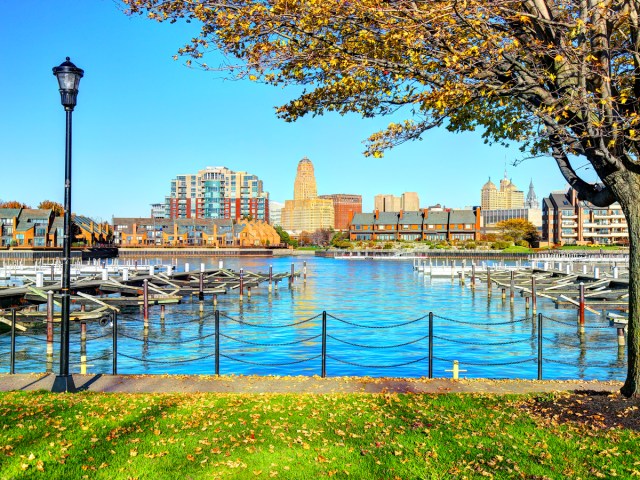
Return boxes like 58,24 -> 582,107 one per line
612,172 -> 640,397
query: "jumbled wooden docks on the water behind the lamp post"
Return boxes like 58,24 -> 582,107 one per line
0,264 -> 300,324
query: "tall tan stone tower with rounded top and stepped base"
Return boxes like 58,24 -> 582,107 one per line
281,157 -> 334,233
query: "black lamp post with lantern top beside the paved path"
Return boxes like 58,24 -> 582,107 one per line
52,57 -> 84,392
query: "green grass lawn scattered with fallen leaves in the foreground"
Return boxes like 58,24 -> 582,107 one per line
0,392 -> 640,480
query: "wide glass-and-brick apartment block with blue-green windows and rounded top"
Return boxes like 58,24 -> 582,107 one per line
165,167 -> 269,222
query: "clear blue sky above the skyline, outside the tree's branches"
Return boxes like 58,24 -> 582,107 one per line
0,0 -> 596,220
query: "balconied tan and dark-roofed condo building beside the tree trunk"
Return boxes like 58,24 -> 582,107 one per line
542,188 -> 629,245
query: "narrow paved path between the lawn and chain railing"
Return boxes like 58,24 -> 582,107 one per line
0,374 -> 622,394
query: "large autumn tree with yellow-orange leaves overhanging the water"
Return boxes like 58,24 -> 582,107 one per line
123,0 -> 640,396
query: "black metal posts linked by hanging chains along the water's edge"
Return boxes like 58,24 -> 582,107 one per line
0,309 -> 621,380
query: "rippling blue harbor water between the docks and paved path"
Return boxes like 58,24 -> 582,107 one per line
0,257 -> 626,380
